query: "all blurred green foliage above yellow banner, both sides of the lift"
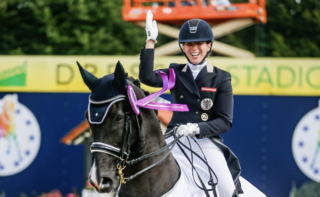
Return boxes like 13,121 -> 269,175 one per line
0,0 -> 320,57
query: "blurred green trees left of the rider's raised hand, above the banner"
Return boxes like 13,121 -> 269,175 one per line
0,0 -> 145,55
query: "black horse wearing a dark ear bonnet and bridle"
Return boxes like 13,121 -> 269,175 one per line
78,62 -> 180,197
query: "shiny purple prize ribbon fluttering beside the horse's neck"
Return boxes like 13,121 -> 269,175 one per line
128,68 -> 189,115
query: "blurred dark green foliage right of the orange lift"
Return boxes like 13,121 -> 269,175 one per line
219,0 -> 320,57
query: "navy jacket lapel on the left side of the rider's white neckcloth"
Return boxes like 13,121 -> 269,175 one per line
177,65 -> 200,98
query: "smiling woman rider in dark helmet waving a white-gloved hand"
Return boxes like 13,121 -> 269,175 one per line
139,11 -> 242,197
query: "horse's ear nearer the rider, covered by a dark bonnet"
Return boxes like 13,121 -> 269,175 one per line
113,61 -> 127,94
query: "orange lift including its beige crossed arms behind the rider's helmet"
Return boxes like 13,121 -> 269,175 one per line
122,0 -> 267,58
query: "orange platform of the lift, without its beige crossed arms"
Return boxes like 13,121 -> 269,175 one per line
122,0 -> 266,24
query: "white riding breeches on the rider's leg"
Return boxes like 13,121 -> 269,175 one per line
166,137 -> 235,197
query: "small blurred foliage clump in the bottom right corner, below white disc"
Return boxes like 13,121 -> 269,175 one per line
289,181 -> 320,197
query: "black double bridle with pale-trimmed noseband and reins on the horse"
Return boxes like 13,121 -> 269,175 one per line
90,112 -> 180,184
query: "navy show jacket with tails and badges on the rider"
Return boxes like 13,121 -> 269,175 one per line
139,48 -> 243,194
